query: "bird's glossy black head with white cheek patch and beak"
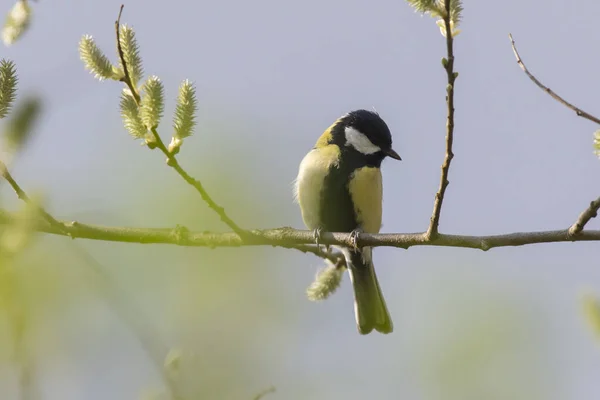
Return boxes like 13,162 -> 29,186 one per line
335,110 -> 401,160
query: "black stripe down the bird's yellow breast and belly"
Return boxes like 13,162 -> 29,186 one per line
319,146 -> 381,232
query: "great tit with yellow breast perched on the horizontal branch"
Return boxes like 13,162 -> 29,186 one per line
295,110 -> 401,335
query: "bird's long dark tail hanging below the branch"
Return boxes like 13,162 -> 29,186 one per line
344,247 -> 394,335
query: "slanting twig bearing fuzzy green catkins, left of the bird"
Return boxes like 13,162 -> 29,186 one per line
115,5 -> 249,236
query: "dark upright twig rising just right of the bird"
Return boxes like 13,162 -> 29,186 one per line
427,1 -> 457,238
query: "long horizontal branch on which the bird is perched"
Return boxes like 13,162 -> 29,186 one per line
0,210 -> 600,252
